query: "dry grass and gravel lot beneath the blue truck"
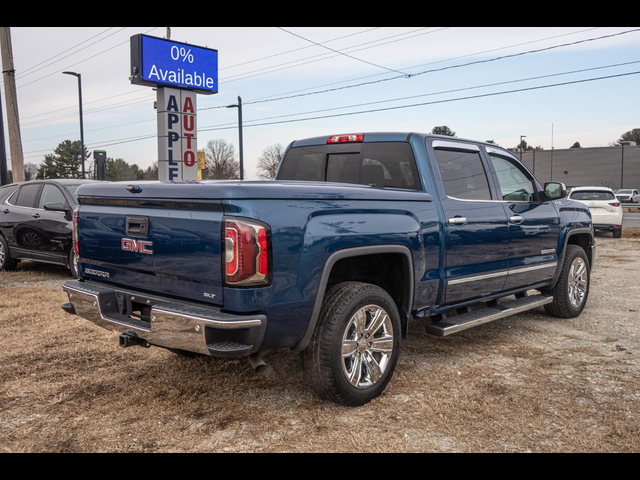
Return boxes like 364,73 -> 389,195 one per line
0,231 -> 640,452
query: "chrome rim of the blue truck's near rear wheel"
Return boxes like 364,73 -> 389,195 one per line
342,305 -> 395,390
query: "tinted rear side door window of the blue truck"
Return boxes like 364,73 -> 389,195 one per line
436,150 -> 492,201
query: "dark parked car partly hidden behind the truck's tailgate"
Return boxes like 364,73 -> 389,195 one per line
0,180 -> 101,278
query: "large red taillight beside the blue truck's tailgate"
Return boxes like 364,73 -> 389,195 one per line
225,219 -> 271,287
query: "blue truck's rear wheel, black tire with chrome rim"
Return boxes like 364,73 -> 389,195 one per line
302,282 -> 402,407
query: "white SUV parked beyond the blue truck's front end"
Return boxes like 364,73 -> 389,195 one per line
569,187 -> 624,238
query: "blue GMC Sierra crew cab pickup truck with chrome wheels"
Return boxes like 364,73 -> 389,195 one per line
63,133 -> 596,406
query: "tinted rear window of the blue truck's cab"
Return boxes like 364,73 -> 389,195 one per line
278,143 -> 422,190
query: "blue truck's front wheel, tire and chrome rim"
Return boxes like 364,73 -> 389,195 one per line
543,245 -> 591,319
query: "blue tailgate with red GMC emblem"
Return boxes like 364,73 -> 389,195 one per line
78,189 -> 224,305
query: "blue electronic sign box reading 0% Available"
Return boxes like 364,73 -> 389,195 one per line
131,35 -> 218,95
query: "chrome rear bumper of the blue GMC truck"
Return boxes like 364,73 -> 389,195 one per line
63,281 -> 267,358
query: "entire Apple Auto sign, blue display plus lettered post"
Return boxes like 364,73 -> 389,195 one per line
131,35 -> 218,182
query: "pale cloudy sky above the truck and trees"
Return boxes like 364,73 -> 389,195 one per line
0,27 -> 640,179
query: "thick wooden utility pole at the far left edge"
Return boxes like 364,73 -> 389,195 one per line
0,27 -> 25,182
